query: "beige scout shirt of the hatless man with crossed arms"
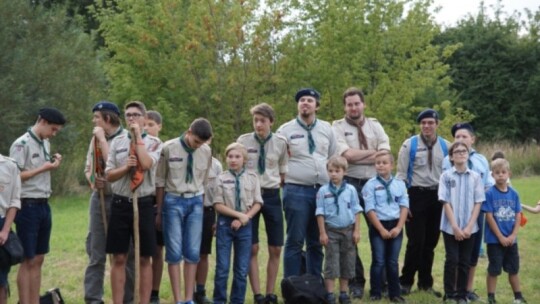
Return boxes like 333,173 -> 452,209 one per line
332,117 -> 390,179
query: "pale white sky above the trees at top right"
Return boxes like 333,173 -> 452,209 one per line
434,0 -> 540,26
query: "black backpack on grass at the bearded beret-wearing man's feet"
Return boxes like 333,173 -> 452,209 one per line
281,273 -> 327,304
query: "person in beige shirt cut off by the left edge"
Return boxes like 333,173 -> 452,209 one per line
0,154 -> 21,304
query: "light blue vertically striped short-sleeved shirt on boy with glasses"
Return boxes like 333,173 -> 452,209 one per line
439,167 -> 486,235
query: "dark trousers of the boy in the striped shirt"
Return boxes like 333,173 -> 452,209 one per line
442,232 -> 477,299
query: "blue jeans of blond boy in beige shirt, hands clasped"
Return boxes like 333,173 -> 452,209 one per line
214,215 -> 252,304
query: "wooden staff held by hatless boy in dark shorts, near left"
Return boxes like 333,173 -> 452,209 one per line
129,128 -> 144,304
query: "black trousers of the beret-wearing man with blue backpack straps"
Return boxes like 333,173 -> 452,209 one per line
399,187 -> 442,289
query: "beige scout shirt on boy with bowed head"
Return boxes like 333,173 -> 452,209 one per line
156,137 -> 212,194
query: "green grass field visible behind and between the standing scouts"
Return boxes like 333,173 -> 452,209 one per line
8,177 -> 540,304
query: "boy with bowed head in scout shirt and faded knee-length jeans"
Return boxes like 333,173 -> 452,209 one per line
156,118 -> 212,304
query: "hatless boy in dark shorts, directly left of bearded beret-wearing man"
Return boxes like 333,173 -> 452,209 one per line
237,103 -> 289,304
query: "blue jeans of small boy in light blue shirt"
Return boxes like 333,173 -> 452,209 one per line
369,220 -> 403,298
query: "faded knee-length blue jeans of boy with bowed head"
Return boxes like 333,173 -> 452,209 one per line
161,193 -> 203,264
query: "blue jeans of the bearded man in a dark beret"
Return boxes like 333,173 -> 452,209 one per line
283,184 -> 323,278
